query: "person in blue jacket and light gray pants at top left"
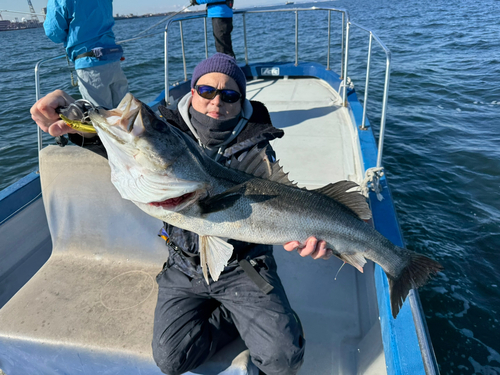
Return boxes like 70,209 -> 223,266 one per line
43,0 -> 128,108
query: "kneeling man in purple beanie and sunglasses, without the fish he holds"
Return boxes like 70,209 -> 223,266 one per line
31,53 -> 333,375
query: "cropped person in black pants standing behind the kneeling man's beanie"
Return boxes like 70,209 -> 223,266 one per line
191,0 -> 235,57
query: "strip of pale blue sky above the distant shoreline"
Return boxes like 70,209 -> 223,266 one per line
0,0 -> 284,21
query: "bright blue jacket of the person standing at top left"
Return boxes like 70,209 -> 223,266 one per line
43,0 -> 122,69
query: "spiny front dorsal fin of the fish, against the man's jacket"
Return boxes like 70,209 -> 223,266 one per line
229,146 -> 296,186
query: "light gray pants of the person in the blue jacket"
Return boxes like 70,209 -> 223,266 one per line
76,61 -> 128,109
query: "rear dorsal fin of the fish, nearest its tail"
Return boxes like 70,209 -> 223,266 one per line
312,181 -> 372,220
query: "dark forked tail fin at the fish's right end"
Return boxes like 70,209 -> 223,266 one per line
386,248 -> 443,319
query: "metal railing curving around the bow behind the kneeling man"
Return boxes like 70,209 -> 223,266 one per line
164,7 -> 391,167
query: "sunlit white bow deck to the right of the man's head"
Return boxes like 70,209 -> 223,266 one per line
247,78 -> 363,188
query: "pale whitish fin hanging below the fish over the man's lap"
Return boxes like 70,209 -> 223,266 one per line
199,236 -> 233,284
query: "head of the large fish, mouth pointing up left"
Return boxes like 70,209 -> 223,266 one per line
89,93 -> 207,211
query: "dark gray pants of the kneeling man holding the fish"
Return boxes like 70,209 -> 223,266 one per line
153,247 -> 305,375
